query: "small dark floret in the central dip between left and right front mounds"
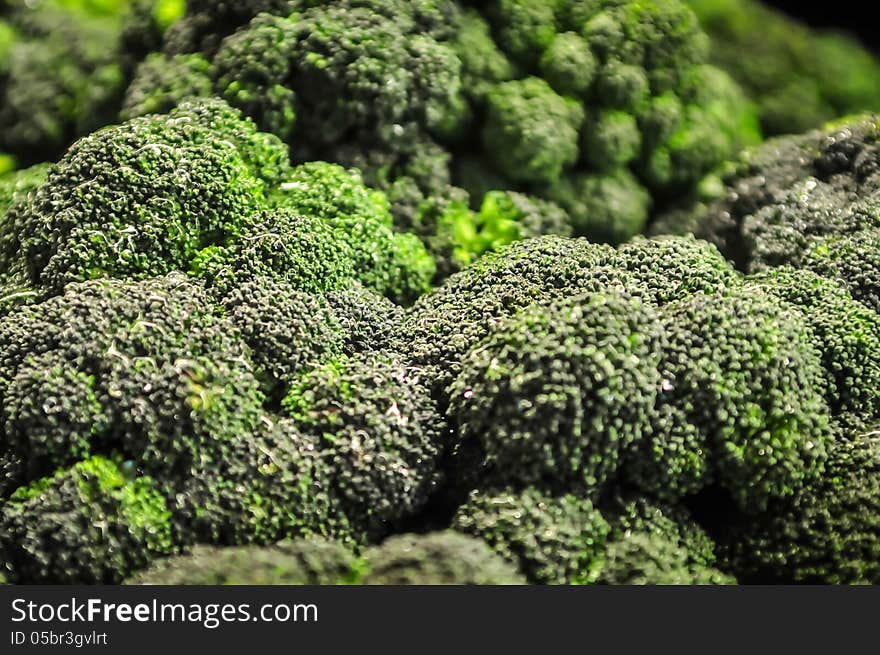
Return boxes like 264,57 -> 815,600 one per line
324,284 -> 406,357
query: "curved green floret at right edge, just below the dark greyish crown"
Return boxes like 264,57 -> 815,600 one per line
748,267 -> 880,422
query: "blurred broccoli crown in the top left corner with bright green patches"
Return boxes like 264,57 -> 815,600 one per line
0,0 -> 127,166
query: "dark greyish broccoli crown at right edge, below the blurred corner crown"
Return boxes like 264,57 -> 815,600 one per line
697,117 -> 880,311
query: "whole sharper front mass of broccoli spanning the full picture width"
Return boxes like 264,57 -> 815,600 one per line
0,99 -> 880,584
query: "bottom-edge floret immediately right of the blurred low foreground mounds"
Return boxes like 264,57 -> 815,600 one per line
452,489 -> 608,584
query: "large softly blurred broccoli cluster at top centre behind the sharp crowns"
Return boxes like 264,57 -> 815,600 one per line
122,0 -> 760,272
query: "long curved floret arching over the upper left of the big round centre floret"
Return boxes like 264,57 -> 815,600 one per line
404,236 -> 614,405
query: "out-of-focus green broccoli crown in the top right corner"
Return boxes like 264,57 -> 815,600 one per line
687,0 -> 880,135
